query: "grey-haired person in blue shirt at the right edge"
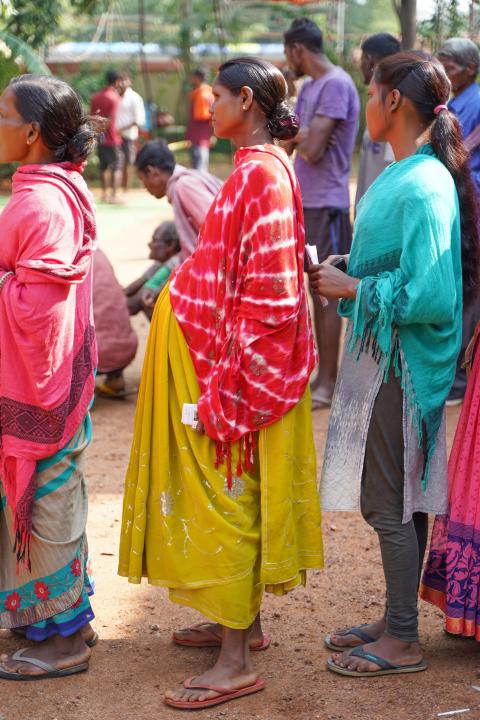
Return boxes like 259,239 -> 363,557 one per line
437,38 -> 480,405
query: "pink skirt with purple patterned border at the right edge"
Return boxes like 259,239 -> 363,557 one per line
420,324 -> 480,641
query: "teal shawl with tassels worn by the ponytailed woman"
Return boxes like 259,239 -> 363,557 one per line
339,145 -> 462,489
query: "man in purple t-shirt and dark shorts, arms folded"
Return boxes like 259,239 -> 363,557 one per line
284,18 -> 360,409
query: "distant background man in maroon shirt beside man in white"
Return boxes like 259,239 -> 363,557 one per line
90,70 -> 122,204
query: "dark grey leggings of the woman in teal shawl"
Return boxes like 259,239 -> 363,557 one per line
361,370 -> 428,642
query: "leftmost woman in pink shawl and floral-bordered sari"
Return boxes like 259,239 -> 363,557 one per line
0,75 -> 104,680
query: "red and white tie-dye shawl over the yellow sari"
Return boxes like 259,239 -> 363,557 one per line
170,145 -> 316,482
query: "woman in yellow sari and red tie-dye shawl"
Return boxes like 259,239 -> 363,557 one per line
119,58 -> 323,709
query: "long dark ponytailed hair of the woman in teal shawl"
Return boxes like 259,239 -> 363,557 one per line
373,51 -> 480,303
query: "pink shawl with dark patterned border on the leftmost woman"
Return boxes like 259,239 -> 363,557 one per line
0,163 -> 97,565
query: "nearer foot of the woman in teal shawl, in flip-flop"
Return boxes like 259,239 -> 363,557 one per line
332,634 -> 423,673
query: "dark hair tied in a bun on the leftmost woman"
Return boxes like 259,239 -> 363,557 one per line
10,75 -> 108,163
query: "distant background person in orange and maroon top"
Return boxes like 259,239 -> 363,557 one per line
185,68 -> 213,172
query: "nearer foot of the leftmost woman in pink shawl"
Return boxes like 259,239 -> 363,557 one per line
0,630 -> 91,675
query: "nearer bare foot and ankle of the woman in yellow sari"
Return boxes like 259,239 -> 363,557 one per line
165,628 -> 258,702
